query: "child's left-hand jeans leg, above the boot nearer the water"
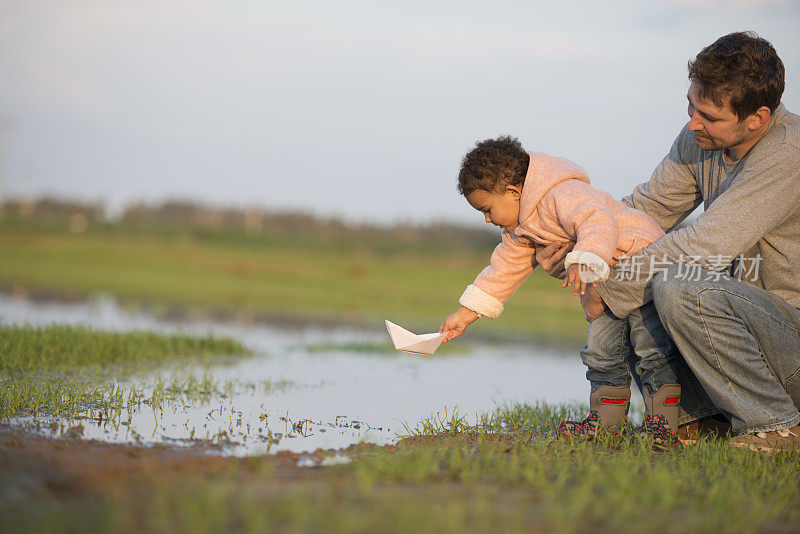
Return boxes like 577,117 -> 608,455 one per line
581,312 -> 636,391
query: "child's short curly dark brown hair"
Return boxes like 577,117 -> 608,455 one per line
458,135 -> 530,196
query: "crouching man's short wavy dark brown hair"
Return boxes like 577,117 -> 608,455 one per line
689,32 -> 785,121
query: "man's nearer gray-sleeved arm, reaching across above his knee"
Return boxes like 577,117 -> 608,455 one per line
597,140 -> 800,317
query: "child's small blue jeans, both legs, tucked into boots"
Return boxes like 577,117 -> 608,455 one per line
581,302 -> 677,393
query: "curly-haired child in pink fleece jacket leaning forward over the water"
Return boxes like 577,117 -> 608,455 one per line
439,137 -> 680,443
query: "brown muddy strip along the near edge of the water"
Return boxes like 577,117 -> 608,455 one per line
0,425 -> 514,510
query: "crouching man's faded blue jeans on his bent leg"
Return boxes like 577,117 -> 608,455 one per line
652,265 -> 800,433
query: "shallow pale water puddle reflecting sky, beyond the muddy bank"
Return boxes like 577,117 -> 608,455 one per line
0,296 -> 600,455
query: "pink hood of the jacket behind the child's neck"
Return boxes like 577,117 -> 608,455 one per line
519,152 -> 589,221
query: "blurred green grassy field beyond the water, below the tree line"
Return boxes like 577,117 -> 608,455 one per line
0,219 -> 586,342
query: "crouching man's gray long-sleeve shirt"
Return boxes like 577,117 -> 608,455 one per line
597,104 -> 800,317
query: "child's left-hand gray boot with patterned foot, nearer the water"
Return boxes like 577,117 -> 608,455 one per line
558,386 -> 631,440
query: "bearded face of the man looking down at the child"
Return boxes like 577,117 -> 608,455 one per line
686,83 -> 752,150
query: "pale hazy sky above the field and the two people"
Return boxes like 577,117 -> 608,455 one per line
0,0 -> 800,224
